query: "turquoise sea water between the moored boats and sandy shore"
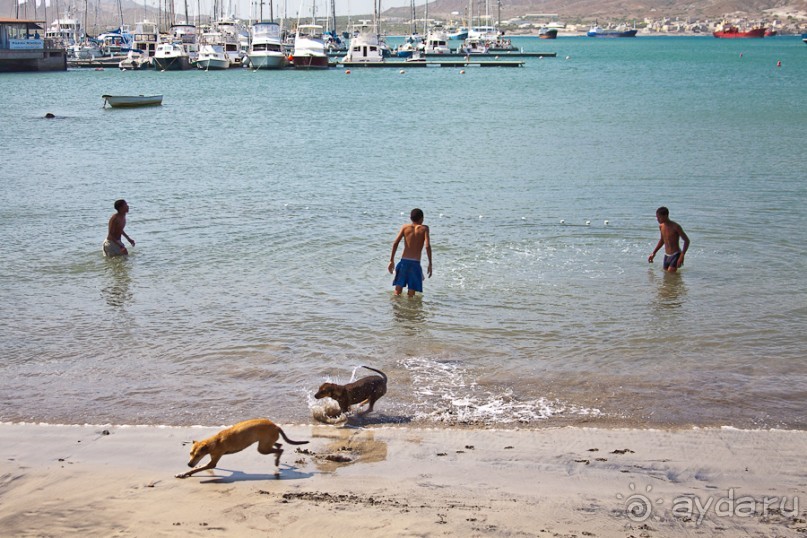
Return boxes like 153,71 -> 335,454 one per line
0,37 -> 807,429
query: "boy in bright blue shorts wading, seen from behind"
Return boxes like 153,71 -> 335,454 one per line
387,208 -> 432,297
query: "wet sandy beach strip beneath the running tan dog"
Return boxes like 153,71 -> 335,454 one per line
0,424 -> 807,537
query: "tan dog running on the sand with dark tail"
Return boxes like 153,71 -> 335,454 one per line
176,418 -> 308,478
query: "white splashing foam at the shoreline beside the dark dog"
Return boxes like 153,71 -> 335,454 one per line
400,357 -> 602,425
